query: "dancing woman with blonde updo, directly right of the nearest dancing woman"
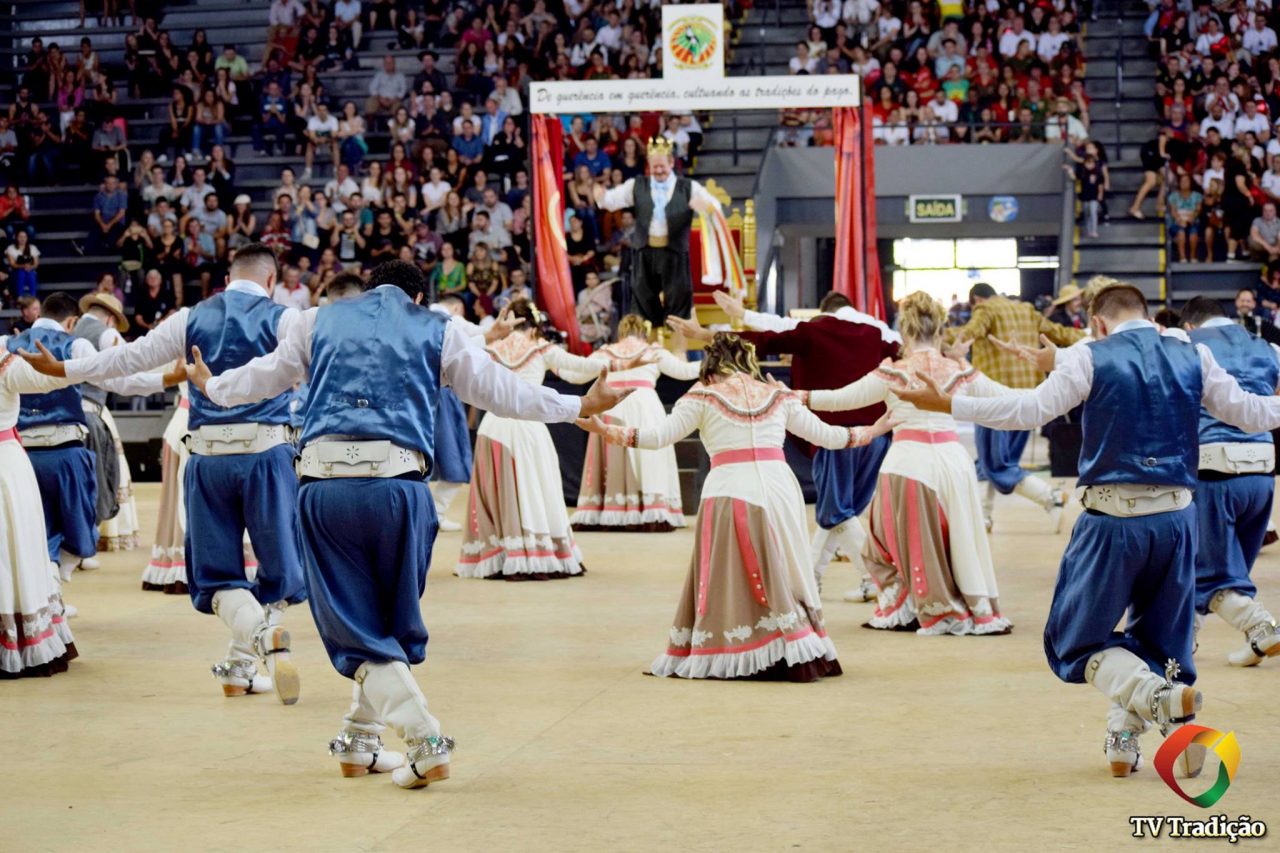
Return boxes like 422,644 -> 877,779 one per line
799,292 -> 1012,635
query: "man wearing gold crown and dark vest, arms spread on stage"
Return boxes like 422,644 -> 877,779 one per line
595,137 -> 721,327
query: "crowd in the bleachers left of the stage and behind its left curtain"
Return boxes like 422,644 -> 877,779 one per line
0,0 -> 721,333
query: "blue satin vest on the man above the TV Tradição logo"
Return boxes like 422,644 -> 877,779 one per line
1079,327 -> 1202,488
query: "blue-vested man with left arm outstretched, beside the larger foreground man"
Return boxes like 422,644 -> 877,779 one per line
23,243 -> 306,704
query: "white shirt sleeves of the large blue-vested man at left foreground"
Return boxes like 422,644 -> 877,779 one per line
205,284 -> 582,424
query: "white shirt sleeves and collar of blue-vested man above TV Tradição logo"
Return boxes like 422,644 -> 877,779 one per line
951,320 -> 1280,433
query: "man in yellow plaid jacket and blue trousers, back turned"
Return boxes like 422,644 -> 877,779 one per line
947,282 -> 1084,533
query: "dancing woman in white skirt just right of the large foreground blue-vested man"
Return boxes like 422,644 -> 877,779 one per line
454,298 -> 640,580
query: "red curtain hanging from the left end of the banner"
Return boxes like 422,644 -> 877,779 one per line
532,115 -> 588,355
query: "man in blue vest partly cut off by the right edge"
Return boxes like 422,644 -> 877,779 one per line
1181,296 -> 1280,666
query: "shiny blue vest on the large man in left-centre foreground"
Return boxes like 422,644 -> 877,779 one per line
302,287 -> 448,464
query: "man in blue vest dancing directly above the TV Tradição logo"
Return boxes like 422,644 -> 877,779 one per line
897,284 -> 1280,776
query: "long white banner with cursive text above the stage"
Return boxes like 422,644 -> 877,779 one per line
529,74 -> 861,114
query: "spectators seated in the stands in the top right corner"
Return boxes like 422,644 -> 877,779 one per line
1130,0 -> 1280,266
